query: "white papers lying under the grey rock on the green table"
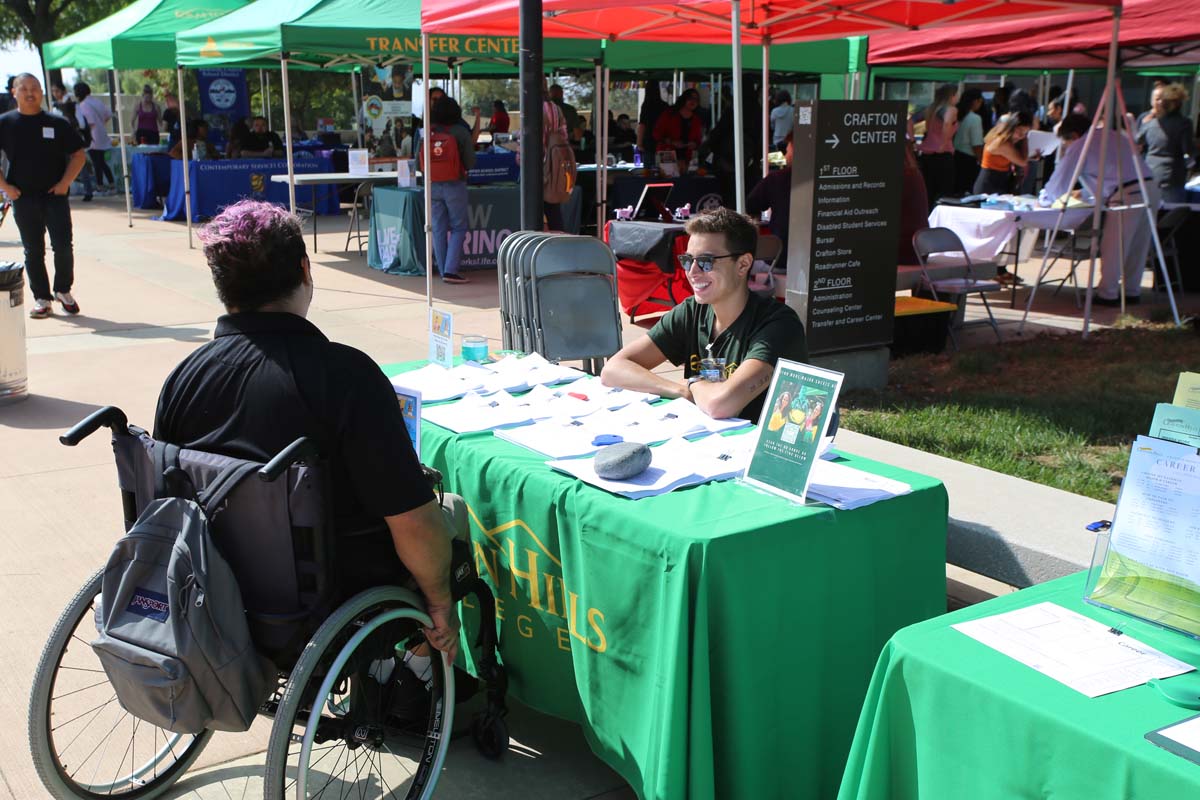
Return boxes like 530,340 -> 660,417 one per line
546,435 -> 754,500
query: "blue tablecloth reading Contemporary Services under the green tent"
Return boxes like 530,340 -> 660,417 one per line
160,156 -> 341,222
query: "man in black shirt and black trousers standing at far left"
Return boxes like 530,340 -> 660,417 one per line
0,72 -> 86,319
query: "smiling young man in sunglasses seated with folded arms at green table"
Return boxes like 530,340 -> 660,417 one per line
600,209 -> 808,421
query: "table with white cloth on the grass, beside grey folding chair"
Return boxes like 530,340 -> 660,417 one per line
929,205 -> 1092,307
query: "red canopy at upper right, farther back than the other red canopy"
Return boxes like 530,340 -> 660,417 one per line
868,0 -> 1200,70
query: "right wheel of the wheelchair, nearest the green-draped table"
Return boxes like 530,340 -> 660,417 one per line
264,587 -> 454,800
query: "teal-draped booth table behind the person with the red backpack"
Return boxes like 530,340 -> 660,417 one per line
367,184 -> 521,275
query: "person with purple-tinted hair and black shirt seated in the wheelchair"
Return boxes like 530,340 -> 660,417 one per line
155,200 -> 458,672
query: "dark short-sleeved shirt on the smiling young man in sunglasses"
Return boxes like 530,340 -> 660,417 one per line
650,294 -> 809,422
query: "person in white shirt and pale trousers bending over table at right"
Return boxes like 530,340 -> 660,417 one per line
1038,114 -> 1162,306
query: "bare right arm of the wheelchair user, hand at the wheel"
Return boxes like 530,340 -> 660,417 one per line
384,500 -> 458,661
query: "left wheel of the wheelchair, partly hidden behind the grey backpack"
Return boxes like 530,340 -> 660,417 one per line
29,570 -> 212,800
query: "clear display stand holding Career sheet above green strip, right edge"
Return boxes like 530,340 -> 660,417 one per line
1088,437 -> 1200,637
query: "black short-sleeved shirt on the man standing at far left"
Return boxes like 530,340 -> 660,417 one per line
0,110 -> 83,196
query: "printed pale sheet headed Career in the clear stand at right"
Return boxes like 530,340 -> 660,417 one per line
1109,437 -> 1200,584
